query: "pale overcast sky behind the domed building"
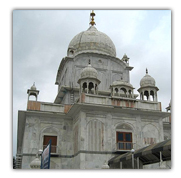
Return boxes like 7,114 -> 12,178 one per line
13,10 -> 171,155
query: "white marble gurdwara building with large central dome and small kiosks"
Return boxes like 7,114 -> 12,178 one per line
17,11 -> 171,169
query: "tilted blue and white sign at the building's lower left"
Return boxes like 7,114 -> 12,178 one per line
41,140 -> 52,169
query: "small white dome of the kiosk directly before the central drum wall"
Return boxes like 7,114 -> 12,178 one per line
81,64 -> 98,79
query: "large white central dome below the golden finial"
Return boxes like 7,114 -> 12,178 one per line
68,26 -> 116,57
